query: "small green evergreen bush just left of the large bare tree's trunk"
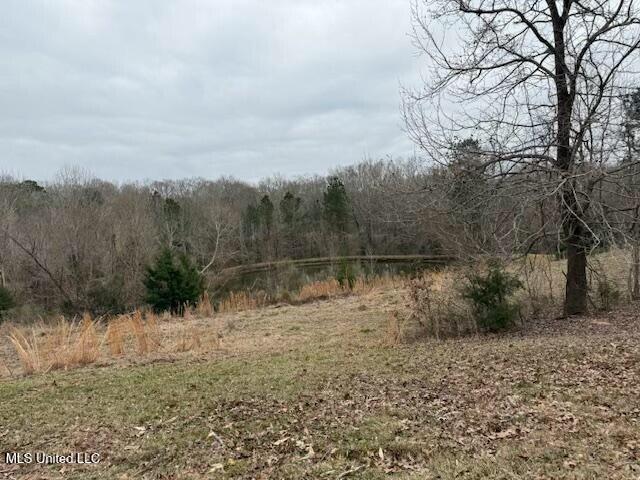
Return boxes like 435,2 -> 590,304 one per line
462,263 -> 522,332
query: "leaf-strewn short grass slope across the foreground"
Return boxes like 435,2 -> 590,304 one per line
0,286 -> 640,479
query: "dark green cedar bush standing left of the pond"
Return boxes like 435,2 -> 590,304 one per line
144,248 -> 204,314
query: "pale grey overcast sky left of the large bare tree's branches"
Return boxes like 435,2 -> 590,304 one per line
0,0 -> 420,182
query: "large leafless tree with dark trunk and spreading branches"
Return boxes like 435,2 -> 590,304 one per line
404,0 -> 640,315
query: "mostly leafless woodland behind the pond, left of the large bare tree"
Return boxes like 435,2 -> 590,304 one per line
0,161 -> 442,313
